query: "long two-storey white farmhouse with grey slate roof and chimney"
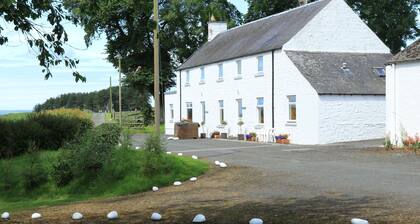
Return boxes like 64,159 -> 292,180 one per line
165,0 -> 392,144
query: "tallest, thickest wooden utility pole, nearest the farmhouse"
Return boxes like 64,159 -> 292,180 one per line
153,0 -> 160,135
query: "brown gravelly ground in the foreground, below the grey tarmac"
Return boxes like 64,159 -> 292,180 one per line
5,167 -> 419,224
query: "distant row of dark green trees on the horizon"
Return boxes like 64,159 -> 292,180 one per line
34,86 -> 152,114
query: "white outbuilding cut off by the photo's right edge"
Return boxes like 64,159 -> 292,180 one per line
386,40 -> 420,146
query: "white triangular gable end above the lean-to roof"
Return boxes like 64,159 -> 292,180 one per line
283,0 -> 390,53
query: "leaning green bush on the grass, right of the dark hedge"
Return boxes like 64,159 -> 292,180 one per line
52,124 -> 121,186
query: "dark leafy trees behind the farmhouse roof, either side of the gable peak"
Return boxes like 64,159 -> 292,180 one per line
245,0 -> 420,54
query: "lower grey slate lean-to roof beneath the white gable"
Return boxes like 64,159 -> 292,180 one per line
286,51 -> 392,95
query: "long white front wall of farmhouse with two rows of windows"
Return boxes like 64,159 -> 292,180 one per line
176,52 -> 271,135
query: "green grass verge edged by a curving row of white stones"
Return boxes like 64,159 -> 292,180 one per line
0,150 -> 209,211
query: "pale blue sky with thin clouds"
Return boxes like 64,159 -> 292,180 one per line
0,0 -> 247,110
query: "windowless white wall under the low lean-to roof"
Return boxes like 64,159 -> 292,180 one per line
319,95 -> 385,144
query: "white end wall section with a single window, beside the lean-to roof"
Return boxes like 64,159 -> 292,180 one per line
274,52 -> 319,144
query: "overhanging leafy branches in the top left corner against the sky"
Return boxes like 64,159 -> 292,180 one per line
0,0 -> 86,82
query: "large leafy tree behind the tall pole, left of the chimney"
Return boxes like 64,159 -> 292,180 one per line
65,0 -> 242,115
